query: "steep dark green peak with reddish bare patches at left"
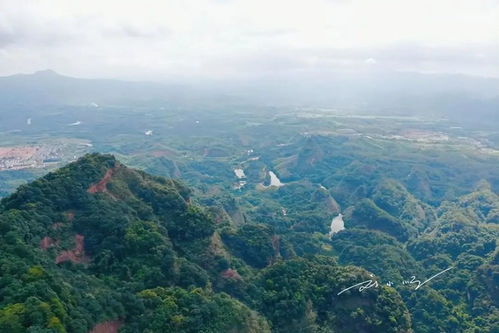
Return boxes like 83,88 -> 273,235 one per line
0,155 -> 268,332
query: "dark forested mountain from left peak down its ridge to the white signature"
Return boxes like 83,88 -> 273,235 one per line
0,154 -> 418,332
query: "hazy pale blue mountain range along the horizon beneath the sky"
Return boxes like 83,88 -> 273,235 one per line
0,69 -> 499,124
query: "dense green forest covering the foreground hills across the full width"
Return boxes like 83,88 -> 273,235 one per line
0,154 -> 499,333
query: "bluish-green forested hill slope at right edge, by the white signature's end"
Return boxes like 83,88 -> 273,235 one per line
331,179 -> 499,333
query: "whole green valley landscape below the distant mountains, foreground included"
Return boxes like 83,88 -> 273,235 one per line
0,72 -> 499,333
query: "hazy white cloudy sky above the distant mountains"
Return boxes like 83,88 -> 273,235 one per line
0,0 -> 499,80
